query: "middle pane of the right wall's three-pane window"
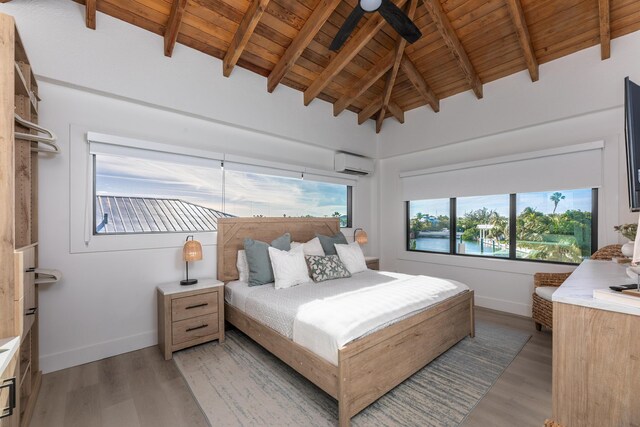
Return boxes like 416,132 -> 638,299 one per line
455,194 -> 509,258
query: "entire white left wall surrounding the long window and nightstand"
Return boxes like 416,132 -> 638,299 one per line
0,1 -> 377,372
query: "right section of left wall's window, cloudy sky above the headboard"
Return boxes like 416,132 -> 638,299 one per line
224,170 -> 352,227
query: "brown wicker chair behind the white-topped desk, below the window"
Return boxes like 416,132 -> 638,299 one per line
531,245 -> 624,331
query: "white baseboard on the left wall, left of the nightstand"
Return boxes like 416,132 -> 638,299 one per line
40,331 -> 158,374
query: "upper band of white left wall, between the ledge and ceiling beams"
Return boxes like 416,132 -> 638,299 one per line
0,0 -> 375,156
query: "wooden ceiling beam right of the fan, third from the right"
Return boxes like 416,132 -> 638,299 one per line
422,0 -> 482,99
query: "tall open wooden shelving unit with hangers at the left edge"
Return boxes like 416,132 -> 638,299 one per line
0,14 -> 42,426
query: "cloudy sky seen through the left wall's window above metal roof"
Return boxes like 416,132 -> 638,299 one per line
96,155 -> 347,217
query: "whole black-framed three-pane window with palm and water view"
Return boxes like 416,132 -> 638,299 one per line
407,189 -> 598,264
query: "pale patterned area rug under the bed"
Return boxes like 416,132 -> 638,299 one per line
174,321 -> 531,427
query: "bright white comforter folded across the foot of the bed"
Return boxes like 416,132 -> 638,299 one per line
293,275 -> 468,365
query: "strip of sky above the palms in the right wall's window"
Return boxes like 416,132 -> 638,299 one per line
410,189 -> 591,217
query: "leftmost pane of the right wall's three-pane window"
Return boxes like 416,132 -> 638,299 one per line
409,199 -> 451,253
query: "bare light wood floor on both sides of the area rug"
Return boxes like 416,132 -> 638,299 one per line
31,308 -> 551,427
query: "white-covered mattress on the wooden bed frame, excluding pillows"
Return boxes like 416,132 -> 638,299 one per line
225,270 -> 469,365
